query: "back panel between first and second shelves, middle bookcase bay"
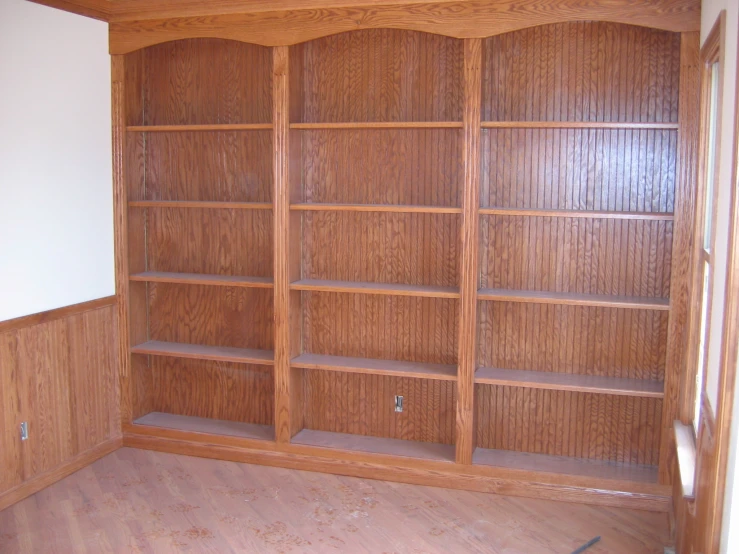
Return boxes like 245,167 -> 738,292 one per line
302,129 -> 463,207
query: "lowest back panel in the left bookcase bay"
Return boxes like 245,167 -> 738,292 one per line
150,356 -> 274,425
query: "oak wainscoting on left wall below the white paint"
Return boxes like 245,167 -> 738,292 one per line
0,296 -> 121,510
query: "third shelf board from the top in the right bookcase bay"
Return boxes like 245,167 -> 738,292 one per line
477,289 -> 670,310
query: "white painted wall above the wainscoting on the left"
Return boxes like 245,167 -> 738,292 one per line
0,0 -> 114,321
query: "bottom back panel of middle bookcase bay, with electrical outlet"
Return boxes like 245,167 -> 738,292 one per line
304,370 -> 456,444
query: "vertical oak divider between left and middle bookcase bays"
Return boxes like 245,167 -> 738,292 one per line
272,46 -> 292,443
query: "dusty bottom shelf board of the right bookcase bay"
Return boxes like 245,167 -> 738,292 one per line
472,448 -> 658,484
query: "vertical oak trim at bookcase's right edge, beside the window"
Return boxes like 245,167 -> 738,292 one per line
659,33 -> 700,484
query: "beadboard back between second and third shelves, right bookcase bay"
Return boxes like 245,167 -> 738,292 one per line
480,216 -> 673,298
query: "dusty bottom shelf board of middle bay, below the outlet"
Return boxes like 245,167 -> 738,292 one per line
291,429 -> 454,462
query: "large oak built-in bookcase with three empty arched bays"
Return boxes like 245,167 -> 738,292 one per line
118,22 -> 692,498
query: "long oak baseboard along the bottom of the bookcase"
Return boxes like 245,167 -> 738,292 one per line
123,426 -> 670,512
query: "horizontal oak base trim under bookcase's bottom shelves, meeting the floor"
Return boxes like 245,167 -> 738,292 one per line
123,425 -> 669,512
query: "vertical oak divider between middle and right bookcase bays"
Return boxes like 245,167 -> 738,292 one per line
456,39 -> 482,464
